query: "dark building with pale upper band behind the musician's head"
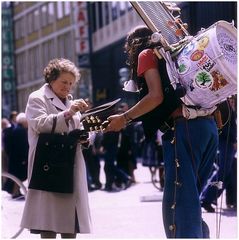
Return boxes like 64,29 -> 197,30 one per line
90,1 -> 237,104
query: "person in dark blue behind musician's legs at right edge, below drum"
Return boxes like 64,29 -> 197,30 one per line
201,97 -> 237,212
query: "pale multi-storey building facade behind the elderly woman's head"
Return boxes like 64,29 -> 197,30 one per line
13,2 -> 92,111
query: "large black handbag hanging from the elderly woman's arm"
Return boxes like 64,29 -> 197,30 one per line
29,117 -> 77,193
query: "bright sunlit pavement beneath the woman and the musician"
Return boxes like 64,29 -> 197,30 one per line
1,164 -> 238,239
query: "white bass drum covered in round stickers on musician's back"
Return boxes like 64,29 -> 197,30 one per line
174,21 -> 237,108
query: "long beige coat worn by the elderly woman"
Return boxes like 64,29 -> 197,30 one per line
21,84 -> 91,233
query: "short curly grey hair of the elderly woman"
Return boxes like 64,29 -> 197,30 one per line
43,58 -> 81,83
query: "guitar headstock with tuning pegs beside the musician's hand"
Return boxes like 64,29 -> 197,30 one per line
81,115 -> 109,132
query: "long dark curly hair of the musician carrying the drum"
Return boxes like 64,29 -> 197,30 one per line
124,25 -> 155,80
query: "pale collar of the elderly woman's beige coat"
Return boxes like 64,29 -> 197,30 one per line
43,83 -> 70,111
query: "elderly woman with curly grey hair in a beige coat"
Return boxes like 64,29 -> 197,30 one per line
21,58 -> 91,238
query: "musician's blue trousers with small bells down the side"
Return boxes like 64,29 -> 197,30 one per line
162,118 -> 218,238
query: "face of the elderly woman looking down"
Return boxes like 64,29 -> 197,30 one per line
50,72 -> 75,99
